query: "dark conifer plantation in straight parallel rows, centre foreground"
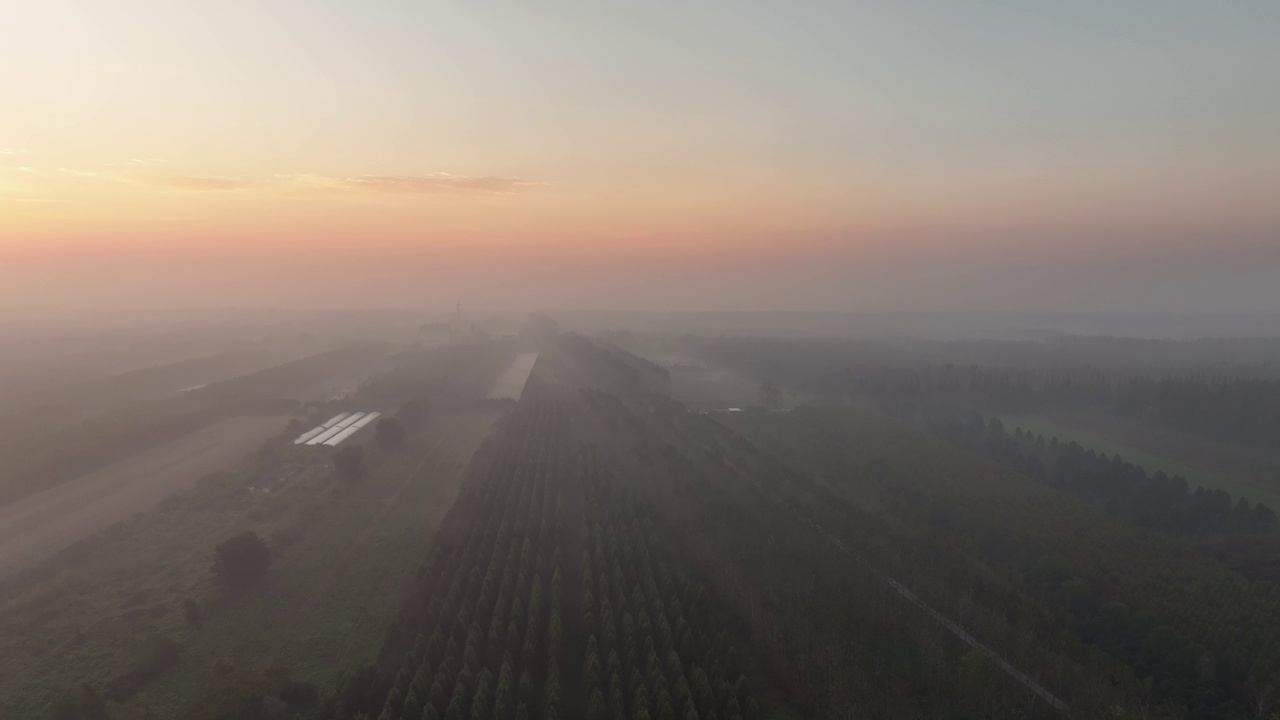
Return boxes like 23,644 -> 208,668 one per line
326,402 -> 758,720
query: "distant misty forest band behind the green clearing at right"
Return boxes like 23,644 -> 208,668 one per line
686,337 -> 1280,448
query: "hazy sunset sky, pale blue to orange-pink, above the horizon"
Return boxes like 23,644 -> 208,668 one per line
0,0 -> 1280,313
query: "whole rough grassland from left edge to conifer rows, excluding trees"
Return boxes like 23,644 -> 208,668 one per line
0,411 -> 498,717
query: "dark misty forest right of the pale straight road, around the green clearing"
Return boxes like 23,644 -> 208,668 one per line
640,338 -> 1280,717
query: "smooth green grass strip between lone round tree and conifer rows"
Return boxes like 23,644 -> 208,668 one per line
138,413 -> 498,711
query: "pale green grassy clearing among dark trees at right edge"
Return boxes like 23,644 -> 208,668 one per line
1001,415 -> 1280,509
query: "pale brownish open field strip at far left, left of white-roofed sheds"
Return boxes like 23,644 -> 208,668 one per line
0,416 -> 288,579
